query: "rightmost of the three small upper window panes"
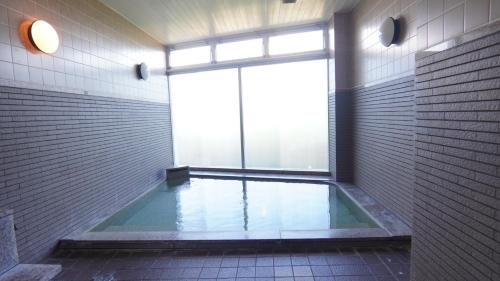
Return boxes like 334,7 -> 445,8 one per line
269,30 -> 324,55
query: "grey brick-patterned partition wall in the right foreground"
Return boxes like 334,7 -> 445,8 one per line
412,30 -> 500,280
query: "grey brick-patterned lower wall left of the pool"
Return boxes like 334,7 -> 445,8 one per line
0,87 -> 172,262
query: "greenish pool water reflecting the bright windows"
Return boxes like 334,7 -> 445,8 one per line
92,178 -> 378,232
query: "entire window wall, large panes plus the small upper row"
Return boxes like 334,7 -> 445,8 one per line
168,26 -> 328,171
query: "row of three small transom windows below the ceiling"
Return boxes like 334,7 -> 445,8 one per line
168,26 -> 328,68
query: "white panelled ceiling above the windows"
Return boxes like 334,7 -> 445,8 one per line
100,0 -> 359,44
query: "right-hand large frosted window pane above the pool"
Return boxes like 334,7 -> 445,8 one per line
242,60 -> 328,171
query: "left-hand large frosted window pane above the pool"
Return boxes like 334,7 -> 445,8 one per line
170,69 -> 241,168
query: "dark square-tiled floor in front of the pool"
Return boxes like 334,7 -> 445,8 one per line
44,246 -> 410,281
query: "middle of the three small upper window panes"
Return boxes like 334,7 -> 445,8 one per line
216,38 -> 263,61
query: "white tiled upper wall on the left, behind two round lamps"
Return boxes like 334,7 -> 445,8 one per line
0,0 -> 168,102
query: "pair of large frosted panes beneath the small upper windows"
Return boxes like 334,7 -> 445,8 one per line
170,60 -> 328,171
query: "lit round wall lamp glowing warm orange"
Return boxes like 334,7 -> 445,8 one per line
28,20 -> 59,54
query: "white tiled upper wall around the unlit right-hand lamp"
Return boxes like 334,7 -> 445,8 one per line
353,0 -> 500,86
